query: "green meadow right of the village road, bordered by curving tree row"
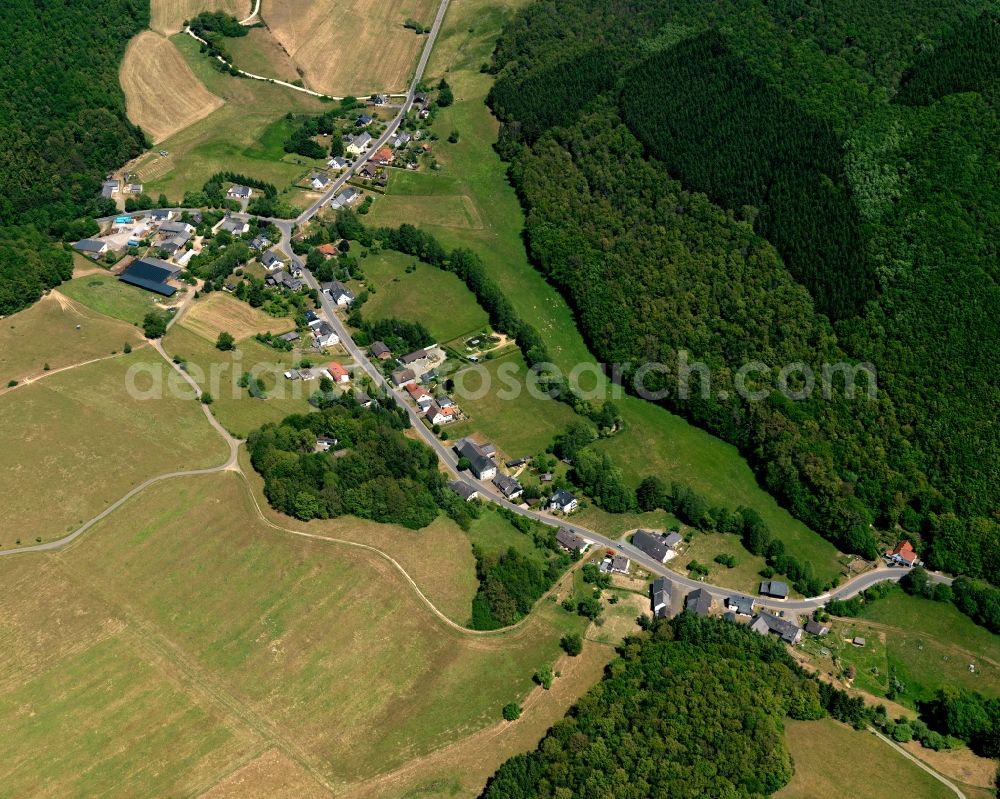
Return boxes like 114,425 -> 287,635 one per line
360,250 -> 489,343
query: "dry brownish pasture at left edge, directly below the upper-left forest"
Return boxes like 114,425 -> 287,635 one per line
0,292 -> 142,392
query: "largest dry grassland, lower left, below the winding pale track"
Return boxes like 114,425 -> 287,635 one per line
0,473 -> 580,796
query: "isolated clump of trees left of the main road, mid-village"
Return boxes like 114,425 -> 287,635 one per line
247,395 -> 451,530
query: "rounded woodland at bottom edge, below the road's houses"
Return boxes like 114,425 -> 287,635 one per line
483,613 -> 864,799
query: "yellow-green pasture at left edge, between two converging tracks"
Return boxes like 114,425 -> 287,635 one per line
0,348 -> 225,548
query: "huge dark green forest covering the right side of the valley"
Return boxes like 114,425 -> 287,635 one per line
490,0 -> 1000,579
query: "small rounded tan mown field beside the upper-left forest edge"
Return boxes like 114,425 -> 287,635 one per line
118,31 -> 223,142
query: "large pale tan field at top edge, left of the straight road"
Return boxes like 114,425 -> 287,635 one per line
261,0 -> 437,96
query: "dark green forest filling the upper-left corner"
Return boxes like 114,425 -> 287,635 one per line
0,0 -> 149,314
